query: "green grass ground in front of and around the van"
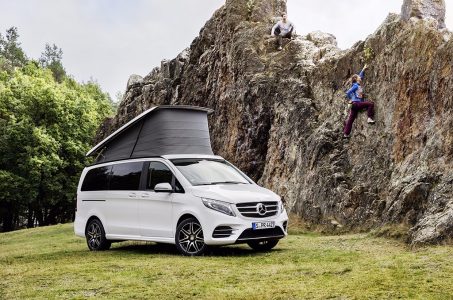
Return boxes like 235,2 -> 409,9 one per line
0,224 -> 453,300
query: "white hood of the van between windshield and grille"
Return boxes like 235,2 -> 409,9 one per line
188,184 -> 280,204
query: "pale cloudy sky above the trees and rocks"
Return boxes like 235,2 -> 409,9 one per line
0,0 -> 453,100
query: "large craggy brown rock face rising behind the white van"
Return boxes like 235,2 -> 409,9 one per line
99,0 -> 453,244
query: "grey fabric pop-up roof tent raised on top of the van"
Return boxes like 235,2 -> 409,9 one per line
86,105 -> 213,163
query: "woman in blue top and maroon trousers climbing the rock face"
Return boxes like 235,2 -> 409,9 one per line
343,65 -> 375,138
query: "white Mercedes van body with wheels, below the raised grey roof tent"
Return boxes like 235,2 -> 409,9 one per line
74,107 -> 288,256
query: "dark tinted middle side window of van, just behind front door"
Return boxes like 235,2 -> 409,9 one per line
110,162 -> 143,191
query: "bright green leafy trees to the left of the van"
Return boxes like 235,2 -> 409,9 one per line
0,61 -> 112,230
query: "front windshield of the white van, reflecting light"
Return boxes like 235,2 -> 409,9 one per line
171,158 -> 250,185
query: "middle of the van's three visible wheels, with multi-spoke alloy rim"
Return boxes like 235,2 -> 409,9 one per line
175,218 -> 206,256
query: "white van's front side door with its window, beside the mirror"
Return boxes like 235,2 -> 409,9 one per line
139,161 -> 175,238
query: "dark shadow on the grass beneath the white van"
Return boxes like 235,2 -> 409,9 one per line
110,242 -> 285,257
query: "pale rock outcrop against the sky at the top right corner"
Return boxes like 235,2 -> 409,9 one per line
401,0 -> 445,28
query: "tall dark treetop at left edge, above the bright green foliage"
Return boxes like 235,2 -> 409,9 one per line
0,27 -> 27,72
